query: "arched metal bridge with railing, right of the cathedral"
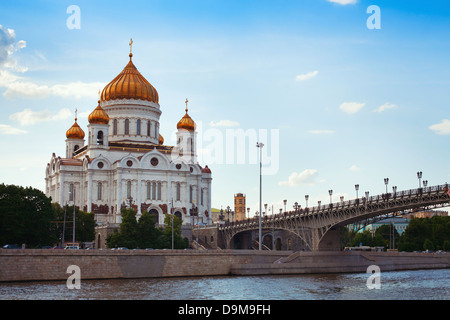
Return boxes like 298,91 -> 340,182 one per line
219,184 -> 450,251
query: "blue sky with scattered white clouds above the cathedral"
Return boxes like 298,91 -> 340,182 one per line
0,0 -> 450,215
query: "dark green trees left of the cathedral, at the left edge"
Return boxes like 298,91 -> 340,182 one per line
0,184 -> 95,248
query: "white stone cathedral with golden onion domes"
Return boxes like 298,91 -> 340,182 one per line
45,42 -> 212,225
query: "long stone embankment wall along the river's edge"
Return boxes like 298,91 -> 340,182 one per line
0,249 -> 450,282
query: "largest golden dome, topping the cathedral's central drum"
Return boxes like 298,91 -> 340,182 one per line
101,53 -> 159,103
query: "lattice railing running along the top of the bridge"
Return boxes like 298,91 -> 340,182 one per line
220,184 -> 450,227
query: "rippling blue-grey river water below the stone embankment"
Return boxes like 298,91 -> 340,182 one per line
0,269 -> 450,301
